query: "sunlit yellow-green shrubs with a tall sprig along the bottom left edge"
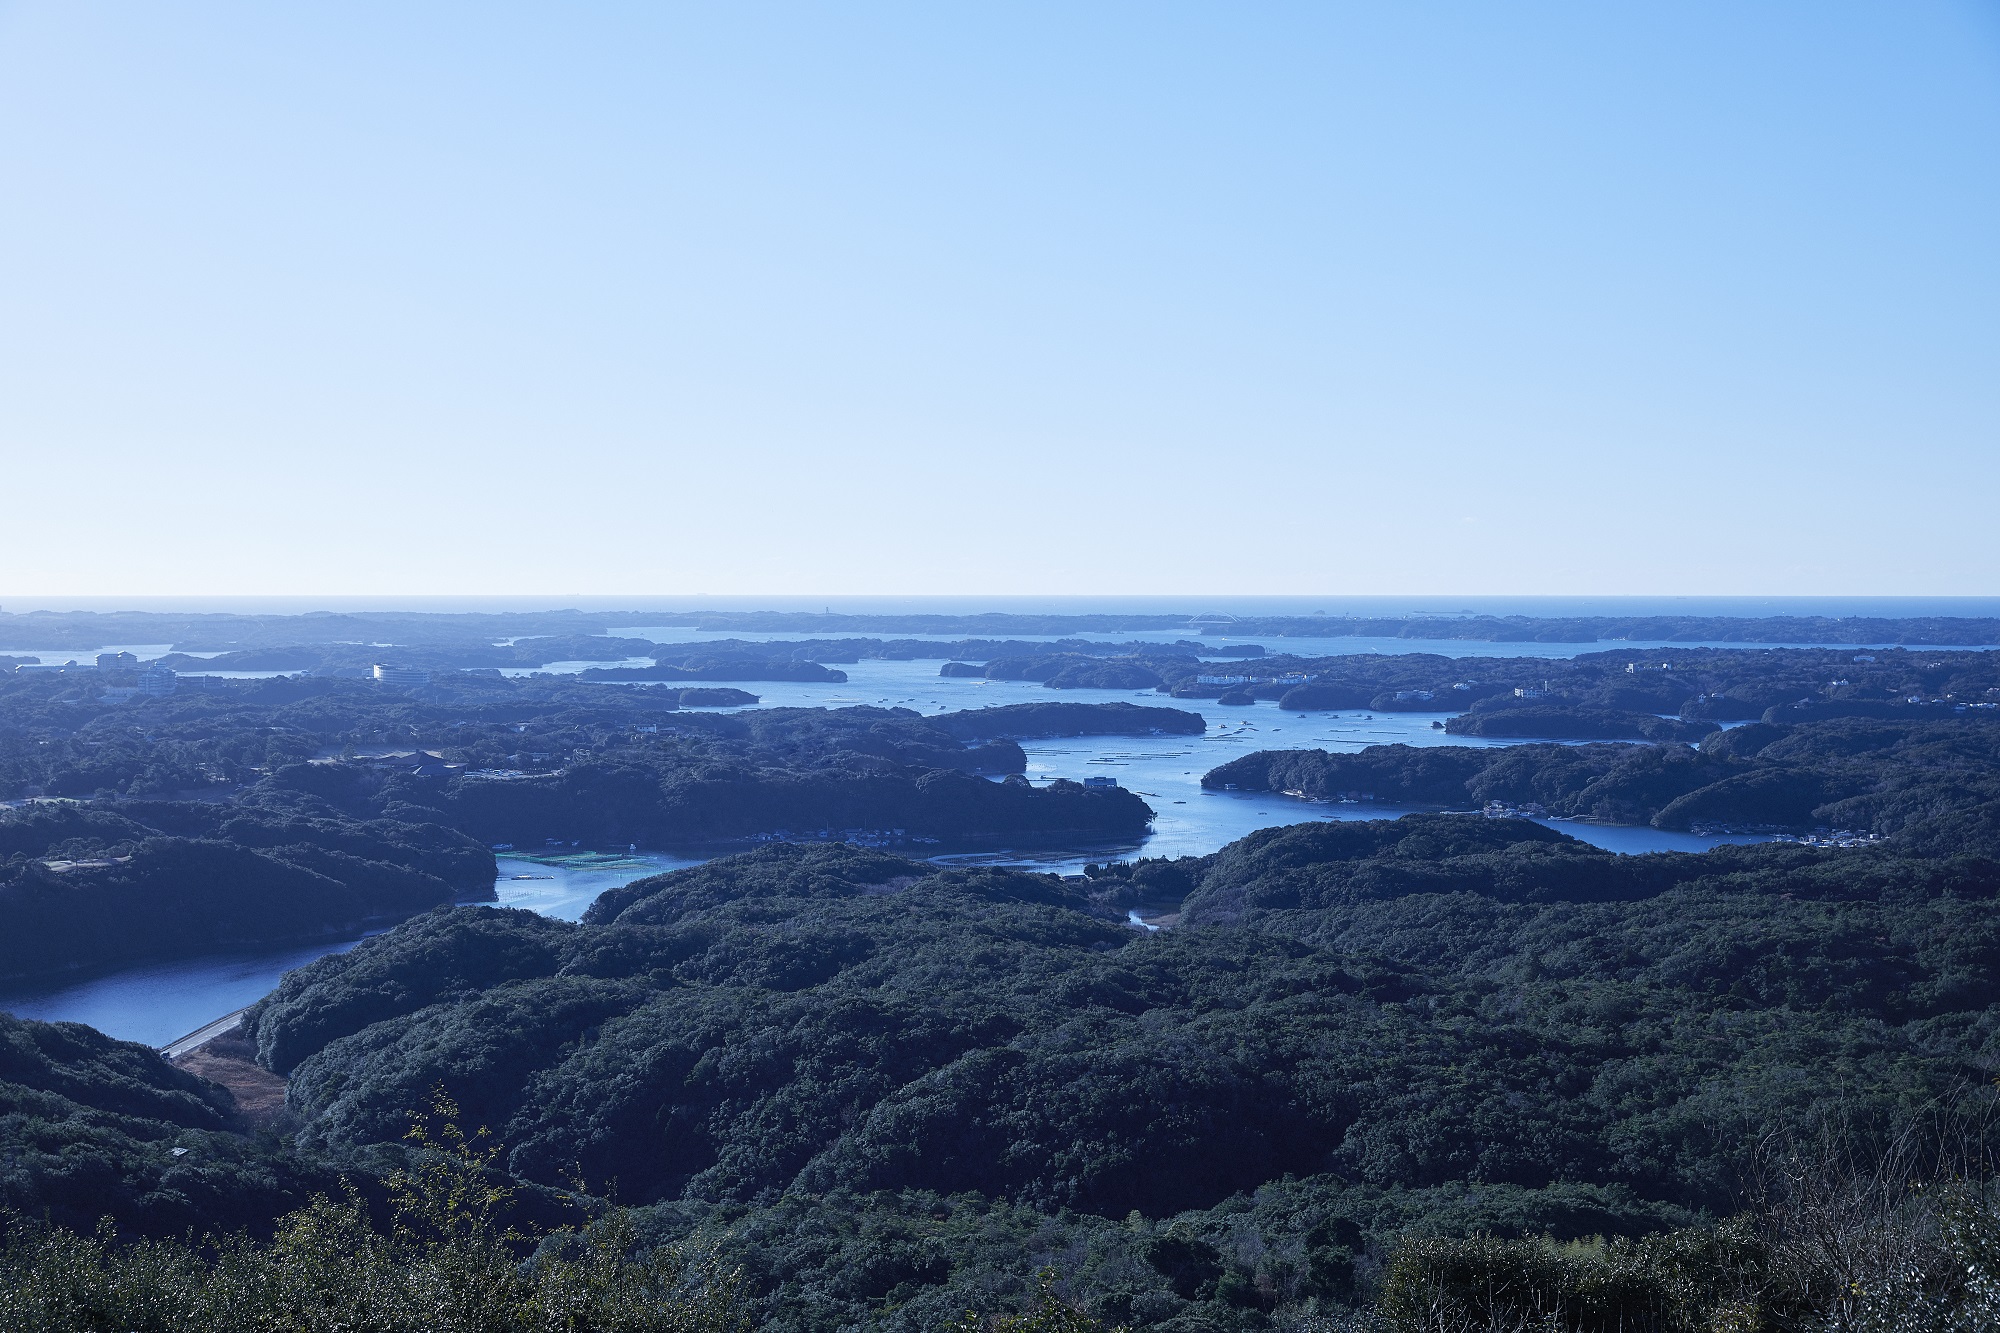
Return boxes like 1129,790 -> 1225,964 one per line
0,1095 -> 748,1333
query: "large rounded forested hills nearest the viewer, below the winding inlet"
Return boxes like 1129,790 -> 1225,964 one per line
199,817 -> 2000,1329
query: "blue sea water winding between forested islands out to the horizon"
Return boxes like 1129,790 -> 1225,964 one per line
0,598 -> 1976,1045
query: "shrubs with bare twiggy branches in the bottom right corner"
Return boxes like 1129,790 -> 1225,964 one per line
1356,1099 -> 2000,1333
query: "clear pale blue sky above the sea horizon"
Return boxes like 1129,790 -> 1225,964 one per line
0,0 -> 2000,600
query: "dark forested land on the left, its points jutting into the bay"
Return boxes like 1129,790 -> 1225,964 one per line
0,675 -> 1168,977
